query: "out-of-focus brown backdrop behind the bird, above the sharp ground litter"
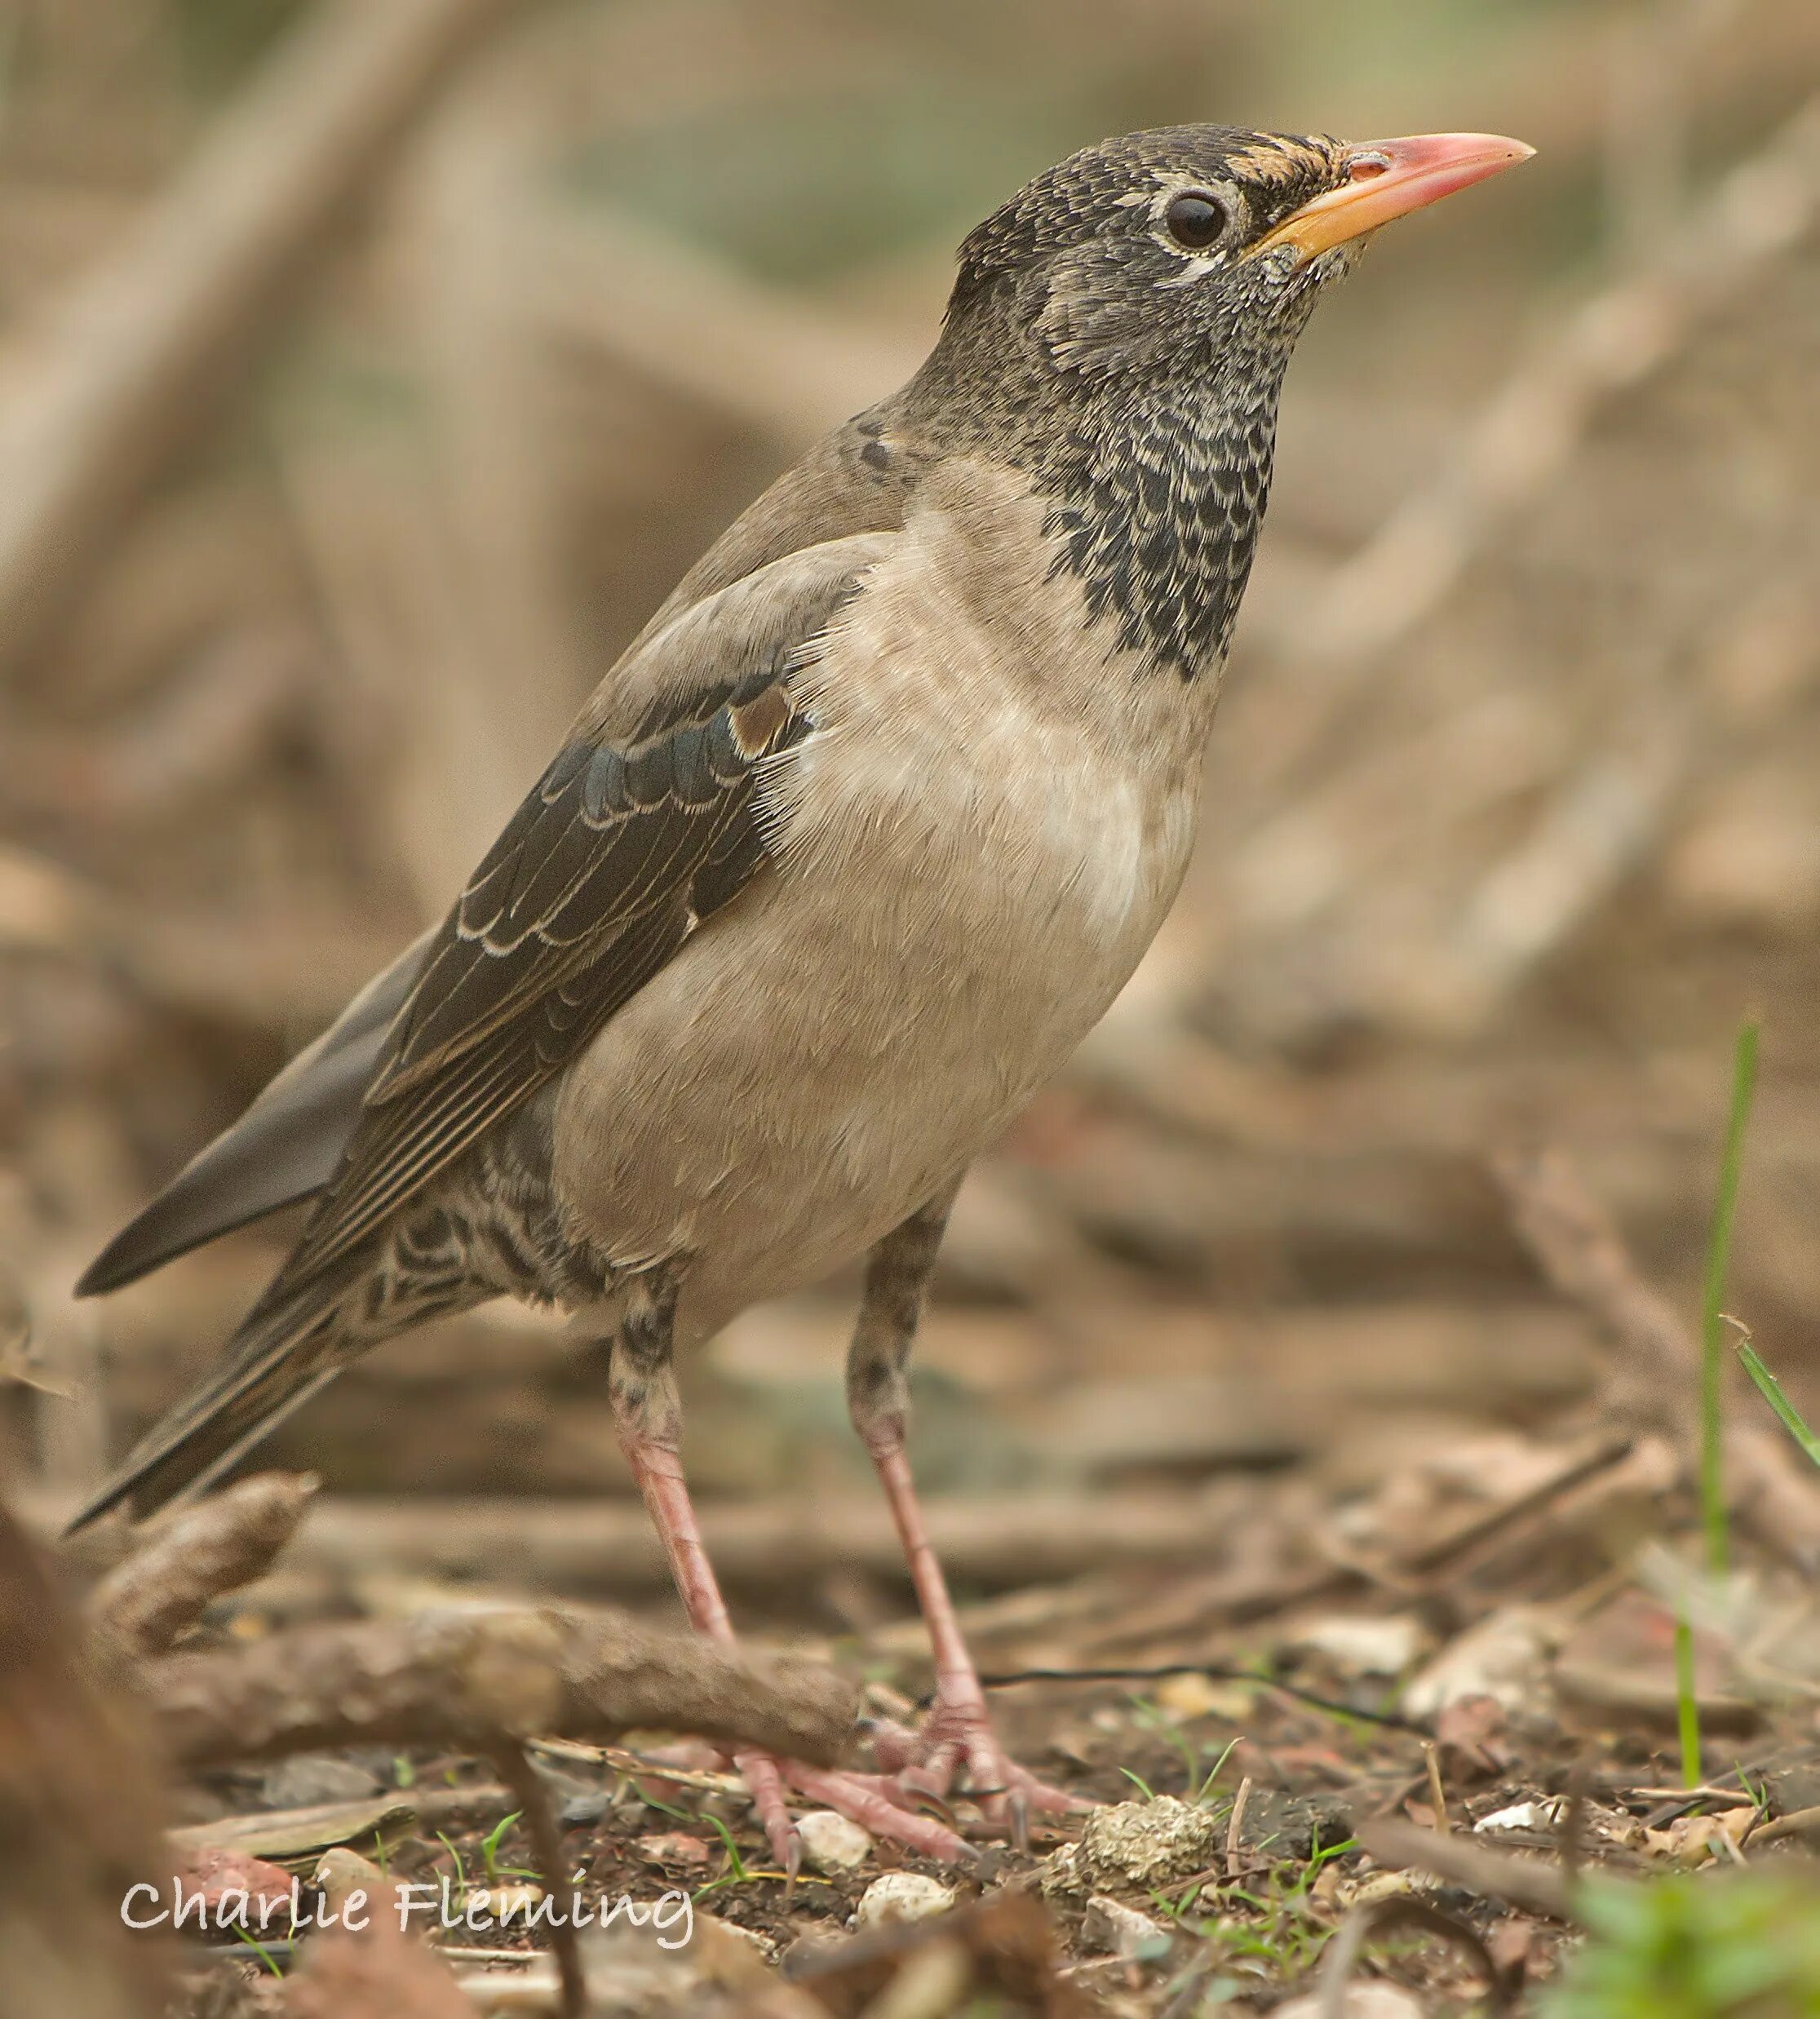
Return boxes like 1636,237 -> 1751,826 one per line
0,0 -> 1820,1619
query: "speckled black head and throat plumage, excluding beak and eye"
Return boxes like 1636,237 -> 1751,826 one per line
907,125 -> 1352,679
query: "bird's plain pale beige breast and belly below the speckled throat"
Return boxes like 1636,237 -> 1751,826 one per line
556,460 -> 1204,1333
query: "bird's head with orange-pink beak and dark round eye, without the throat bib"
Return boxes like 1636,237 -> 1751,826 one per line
950,125 -> 1533,382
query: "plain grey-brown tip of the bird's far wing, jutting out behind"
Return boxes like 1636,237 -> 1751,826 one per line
77,927 -> 436,1296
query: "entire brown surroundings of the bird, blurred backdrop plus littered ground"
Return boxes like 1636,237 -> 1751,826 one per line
0,0 -> 1820,2019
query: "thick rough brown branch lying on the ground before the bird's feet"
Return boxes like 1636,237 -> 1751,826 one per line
135,1609 -> 857,1767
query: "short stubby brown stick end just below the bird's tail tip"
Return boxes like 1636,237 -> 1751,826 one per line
85,1472 -> 317,1659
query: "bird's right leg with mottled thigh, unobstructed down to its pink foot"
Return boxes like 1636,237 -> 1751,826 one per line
847,1181 -> 1081,1841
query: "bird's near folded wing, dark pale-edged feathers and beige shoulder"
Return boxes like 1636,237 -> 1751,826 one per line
241,533 -> 895,1296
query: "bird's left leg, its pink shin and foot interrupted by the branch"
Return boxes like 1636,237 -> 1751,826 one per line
608,1278 -> 973,1880
